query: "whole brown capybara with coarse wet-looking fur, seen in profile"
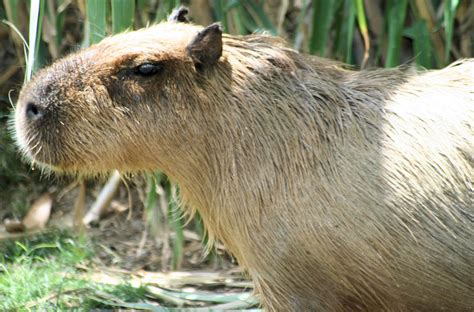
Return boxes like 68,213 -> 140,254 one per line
15,7 -> 474,311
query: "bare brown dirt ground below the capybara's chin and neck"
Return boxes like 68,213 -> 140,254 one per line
33,177 -> 236,271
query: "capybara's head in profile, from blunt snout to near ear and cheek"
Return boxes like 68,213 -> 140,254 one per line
15,9 -> 227,176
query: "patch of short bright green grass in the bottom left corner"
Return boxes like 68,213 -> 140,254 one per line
0,232 -> 150,311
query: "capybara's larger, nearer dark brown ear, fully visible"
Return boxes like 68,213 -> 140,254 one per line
187,23 -> 222,67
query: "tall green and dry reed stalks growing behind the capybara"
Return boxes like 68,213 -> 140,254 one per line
0,0 -> 474,310
